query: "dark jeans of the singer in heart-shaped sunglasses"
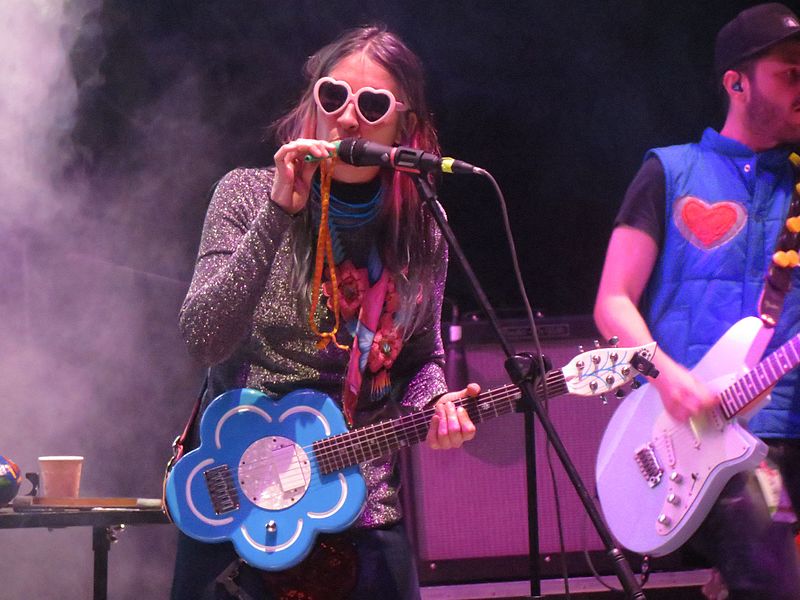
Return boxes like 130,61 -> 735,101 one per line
171,524 -> 420,600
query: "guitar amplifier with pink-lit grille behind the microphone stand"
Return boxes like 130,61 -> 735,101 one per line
404,315 -> 632,583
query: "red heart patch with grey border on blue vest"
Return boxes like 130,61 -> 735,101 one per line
673,196 -> 747,250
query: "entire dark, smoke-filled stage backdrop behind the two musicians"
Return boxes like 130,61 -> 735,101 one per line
0,0 -> 798,598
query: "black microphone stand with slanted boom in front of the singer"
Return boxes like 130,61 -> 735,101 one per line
409,173 -> 645,600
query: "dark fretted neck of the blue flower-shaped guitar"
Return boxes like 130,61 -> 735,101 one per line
314,369 -> 567,474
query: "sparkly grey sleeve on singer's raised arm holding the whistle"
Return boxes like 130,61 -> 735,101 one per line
180,169 -> 292,366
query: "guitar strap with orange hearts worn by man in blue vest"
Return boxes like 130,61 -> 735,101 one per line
758,152 -> 800,327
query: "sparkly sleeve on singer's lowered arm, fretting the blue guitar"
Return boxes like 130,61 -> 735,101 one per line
402,217 -> 447,409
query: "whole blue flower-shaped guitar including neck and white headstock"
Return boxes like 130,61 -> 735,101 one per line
165,343 -> 655,571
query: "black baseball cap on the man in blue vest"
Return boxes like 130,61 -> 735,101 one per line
714,2 -> 800,77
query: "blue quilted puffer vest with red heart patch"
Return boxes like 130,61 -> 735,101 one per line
643,129 -> 800,437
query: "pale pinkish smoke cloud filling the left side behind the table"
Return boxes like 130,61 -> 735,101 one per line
0,0 -> 206,599
